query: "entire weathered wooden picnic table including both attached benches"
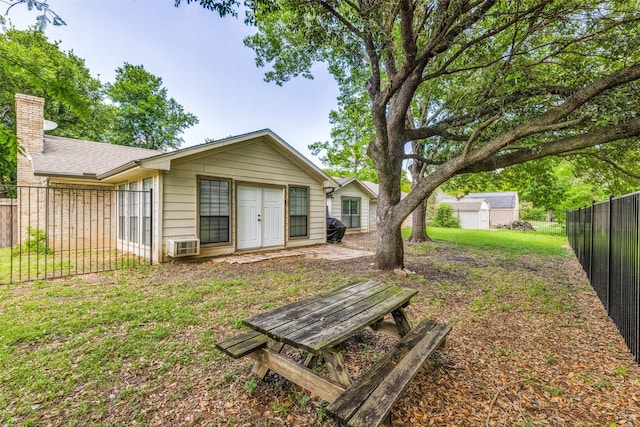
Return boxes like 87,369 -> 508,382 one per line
216,281 -> 450,426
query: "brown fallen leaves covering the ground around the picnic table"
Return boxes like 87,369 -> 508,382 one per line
2,235 -> 640,427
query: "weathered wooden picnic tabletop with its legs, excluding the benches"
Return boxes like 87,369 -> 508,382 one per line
238,281 -> 418,402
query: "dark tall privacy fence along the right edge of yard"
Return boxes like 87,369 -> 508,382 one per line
567,193 -> 640,363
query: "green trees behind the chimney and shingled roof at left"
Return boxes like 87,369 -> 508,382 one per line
0,21 -> 197,191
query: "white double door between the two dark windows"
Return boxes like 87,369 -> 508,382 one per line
236,185 -> 284,249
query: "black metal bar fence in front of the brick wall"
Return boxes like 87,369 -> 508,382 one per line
0,186 -> 153,285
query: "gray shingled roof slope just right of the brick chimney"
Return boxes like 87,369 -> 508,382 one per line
30,135 -> 163,177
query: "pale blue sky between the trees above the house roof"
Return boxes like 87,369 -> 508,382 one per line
5,0 -> 338,165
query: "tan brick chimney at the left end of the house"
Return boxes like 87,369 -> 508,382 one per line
16,93 -> 44,185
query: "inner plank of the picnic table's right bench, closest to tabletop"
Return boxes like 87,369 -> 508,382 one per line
327,321 -> 436,424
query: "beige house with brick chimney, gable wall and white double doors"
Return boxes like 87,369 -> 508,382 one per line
16,94 -> 339,262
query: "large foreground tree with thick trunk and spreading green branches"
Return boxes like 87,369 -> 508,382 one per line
184,0 -> 640,269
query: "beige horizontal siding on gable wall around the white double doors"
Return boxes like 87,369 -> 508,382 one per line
162,139 -> 326,257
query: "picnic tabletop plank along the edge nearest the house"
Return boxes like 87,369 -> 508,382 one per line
244,281 -> 381,329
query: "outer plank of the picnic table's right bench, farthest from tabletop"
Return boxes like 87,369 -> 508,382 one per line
349,324 -> 451,427
